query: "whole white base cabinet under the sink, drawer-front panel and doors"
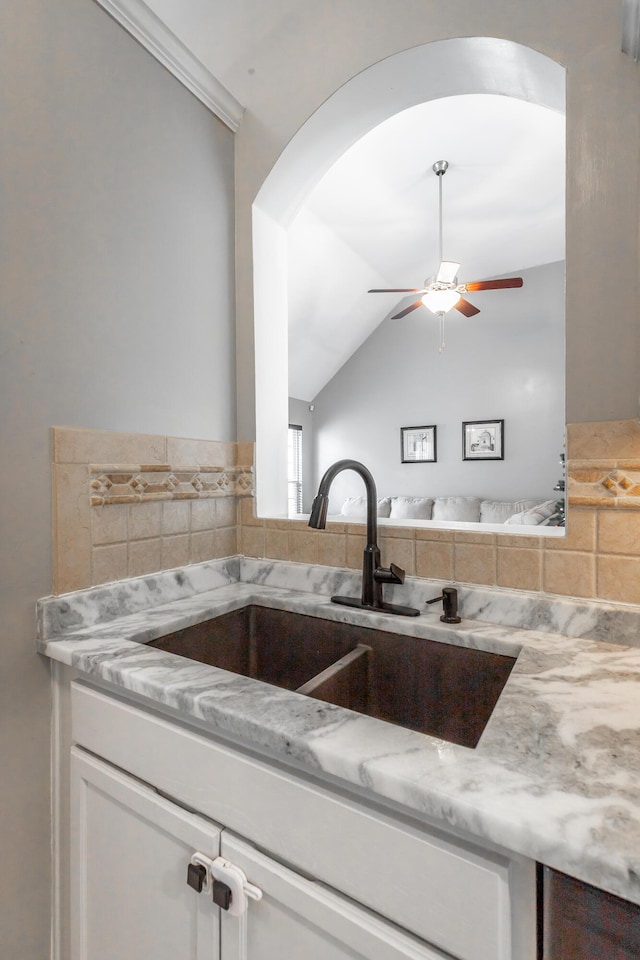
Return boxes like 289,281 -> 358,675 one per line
72,682 -> 536,960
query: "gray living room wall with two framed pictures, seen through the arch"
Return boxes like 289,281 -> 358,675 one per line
313,263 -> 565,512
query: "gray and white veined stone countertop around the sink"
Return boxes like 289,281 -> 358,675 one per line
38,558 -> 640,904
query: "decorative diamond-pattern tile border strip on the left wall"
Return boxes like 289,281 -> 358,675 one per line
89,463 -> 253,507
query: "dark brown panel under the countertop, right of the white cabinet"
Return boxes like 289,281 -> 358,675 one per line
542,867 -> 640,960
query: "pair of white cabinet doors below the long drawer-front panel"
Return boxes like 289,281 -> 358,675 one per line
71,748 -> 450,960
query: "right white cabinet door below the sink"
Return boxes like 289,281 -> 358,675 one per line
221,831 -> 449,960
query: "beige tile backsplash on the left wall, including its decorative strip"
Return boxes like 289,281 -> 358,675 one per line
53,427 -> 253,593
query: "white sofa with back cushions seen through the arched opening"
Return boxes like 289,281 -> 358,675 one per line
340,497 -> 557,526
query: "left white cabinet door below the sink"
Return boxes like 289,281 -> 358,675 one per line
71,747 -> 220,960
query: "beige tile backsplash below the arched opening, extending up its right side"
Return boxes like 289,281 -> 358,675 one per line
240,420 -> 640,604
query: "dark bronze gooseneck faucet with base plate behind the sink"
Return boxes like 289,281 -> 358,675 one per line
309,460 -> 420,617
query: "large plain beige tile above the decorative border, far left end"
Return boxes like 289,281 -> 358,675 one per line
53,427 -> 167,464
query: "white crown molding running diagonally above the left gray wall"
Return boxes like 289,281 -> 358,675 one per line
96,0 -> 244,133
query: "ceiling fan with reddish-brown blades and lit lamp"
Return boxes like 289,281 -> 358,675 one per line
368,160 -> 523,336
